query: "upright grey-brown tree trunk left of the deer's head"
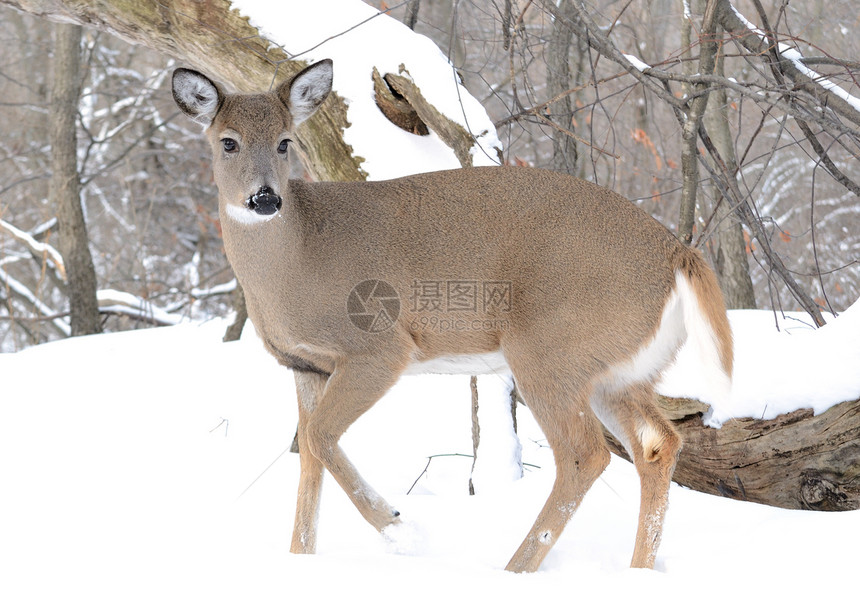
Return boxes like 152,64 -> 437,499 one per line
49,24 -> 102,336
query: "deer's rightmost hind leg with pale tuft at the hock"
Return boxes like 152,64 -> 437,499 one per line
593,383 -> 681,569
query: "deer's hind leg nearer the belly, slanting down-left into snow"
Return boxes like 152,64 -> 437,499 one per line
506,371 -> 609,572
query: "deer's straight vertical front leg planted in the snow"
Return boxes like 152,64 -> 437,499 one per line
290,371 -> 328,554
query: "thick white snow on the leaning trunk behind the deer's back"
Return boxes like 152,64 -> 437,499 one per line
233,0 -> 501,180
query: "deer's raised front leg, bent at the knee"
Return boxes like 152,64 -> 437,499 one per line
299,359 -> 400,531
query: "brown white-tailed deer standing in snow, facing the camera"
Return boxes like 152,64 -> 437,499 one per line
173,60 -> 732,571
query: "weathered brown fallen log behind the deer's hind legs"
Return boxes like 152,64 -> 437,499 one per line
607,397 -> 860,511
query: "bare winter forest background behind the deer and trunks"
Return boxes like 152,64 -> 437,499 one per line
0,0 -> 860,352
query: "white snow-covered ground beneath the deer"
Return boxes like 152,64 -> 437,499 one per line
0,305 -> 860,614
